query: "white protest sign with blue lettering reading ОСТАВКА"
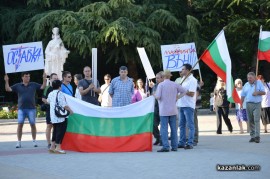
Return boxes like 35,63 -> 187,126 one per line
3,42 -> 44,73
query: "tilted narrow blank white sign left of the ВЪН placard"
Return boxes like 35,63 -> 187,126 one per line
137,47 -> 156,79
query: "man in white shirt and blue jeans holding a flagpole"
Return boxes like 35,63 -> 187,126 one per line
177,64 -> 197,149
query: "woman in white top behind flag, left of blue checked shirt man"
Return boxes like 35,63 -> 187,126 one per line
99,74 -> 112,107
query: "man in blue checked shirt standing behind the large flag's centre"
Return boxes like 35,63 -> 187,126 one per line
109,66 -> 134,107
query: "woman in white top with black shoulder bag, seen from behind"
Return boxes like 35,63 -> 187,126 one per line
47,80 -> 73,154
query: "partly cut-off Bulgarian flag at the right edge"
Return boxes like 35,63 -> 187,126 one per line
258,30 -> 270,62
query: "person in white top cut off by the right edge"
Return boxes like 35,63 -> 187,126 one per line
257,75 -> 270,133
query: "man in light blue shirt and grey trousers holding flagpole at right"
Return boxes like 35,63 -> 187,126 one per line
240,72 -> 265,143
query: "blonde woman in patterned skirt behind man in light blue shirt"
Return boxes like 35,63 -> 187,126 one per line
234,79 -> 249,134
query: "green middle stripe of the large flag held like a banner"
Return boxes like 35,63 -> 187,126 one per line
67,113 -> 154,137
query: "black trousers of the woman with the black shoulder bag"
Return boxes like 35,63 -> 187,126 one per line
52,119 -> 67,144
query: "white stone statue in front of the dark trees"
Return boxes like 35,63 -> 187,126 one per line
45,27 -> 70,79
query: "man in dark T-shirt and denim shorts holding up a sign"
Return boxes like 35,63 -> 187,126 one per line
4,72 -> 47,148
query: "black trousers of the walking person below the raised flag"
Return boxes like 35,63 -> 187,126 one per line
216,107 -> 233,134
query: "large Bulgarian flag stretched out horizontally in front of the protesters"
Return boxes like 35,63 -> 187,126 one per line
62,95 -> 155,152
